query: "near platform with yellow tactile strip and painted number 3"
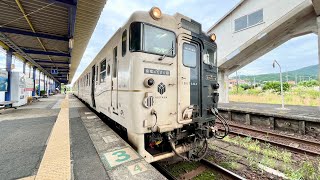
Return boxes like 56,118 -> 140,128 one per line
0,94 -> 165,180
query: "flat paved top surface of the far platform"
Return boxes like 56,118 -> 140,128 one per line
219,102 -> 320,122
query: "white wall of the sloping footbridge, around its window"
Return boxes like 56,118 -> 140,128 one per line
210,0 -> 309,64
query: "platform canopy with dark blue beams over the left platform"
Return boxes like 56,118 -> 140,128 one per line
0,0 -> 106,83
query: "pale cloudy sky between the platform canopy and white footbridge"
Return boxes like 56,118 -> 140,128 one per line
73,0 -> 239,82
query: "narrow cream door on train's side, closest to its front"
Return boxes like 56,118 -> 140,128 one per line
111,47 -> 118,114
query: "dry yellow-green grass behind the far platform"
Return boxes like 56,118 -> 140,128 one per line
229,87 -> 320,106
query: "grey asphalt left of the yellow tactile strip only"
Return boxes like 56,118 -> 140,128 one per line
0,96 -> 64,179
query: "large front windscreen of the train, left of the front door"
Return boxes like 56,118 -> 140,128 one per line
130,22 -> 176,57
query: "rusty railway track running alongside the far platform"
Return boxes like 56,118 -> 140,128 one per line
217,122 -> 320,156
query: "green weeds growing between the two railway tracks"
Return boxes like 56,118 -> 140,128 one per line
221,136 -> 320,180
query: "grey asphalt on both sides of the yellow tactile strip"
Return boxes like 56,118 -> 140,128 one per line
0,95 -> 108,180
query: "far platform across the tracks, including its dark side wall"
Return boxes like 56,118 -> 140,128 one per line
218,102 -> 320,136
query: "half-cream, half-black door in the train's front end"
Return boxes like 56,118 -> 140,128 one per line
178,35 -> 202,123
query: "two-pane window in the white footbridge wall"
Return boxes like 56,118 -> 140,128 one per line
234,9 -> 263,32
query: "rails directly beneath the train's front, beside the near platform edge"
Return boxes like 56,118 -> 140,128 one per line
152,159 -> 245,180
